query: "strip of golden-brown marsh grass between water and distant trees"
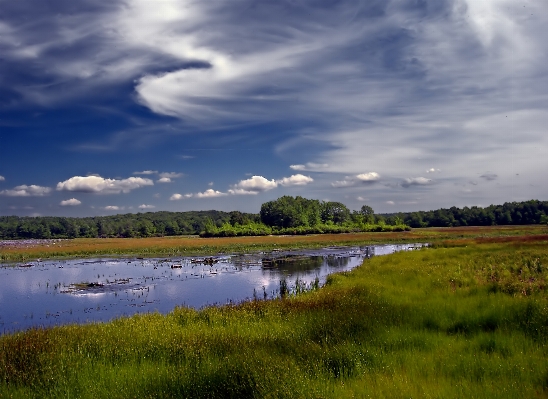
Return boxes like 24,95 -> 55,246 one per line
0,225 -> 548,262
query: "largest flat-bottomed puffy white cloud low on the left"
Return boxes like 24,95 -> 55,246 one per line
57,176 -> 154,194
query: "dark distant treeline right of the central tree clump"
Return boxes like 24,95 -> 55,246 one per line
383,200 -> 548,227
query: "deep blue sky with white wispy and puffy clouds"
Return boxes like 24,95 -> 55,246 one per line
0,0 -> 548,216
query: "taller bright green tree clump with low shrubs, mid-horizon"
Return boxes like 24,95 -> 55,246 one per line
200,196 -> 409,237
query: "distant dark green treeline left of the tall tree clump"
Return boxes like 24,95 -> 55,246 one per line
0,211 -> 258,240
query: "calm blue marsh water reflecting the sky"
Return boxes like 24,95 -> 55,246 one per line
0,244 -> 422,333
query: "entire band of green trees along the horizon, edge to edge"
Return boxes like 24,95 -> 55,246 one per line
0,196 -> 548,240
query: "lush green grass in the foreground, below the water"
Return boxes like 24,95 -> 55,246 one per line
0,238 -> 548,398
